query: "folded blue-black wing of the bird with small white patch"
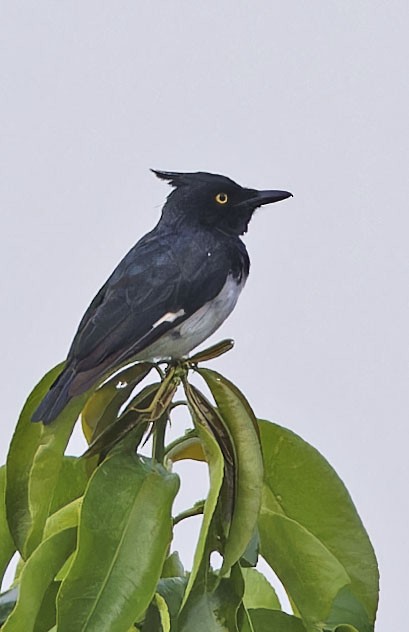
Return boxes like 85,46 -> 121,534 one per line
67,233 -> 229,373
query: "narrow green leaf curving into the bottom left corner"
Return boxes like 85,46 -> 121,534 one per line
1,529 -> 76,632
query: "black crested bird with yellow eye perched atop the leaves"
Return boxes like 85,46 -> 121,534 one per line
32,169 -> 292,425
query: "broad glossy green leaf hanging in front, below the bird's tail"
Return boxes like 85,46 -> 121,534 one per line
57,453 -> 179,632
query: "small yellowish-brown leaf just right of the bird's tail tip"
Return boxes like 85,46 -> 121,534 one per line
81,362 -> 153,443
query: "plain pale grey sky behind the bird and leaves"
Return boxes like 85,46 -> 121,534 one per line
0,0 -> 409,632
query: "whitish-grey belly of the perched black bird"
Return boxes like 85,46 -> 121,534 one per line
136,276 -> 245,360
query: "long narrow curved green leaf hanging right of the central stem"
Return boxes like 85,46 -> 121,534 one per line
198,369 -> 263,574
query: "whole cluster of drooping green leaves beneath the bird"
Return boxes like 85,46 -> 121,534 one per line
0,341 -> 378,632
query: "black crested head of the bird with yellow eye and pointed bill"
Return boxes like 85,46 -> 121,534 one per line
152,169 -> 292,235
